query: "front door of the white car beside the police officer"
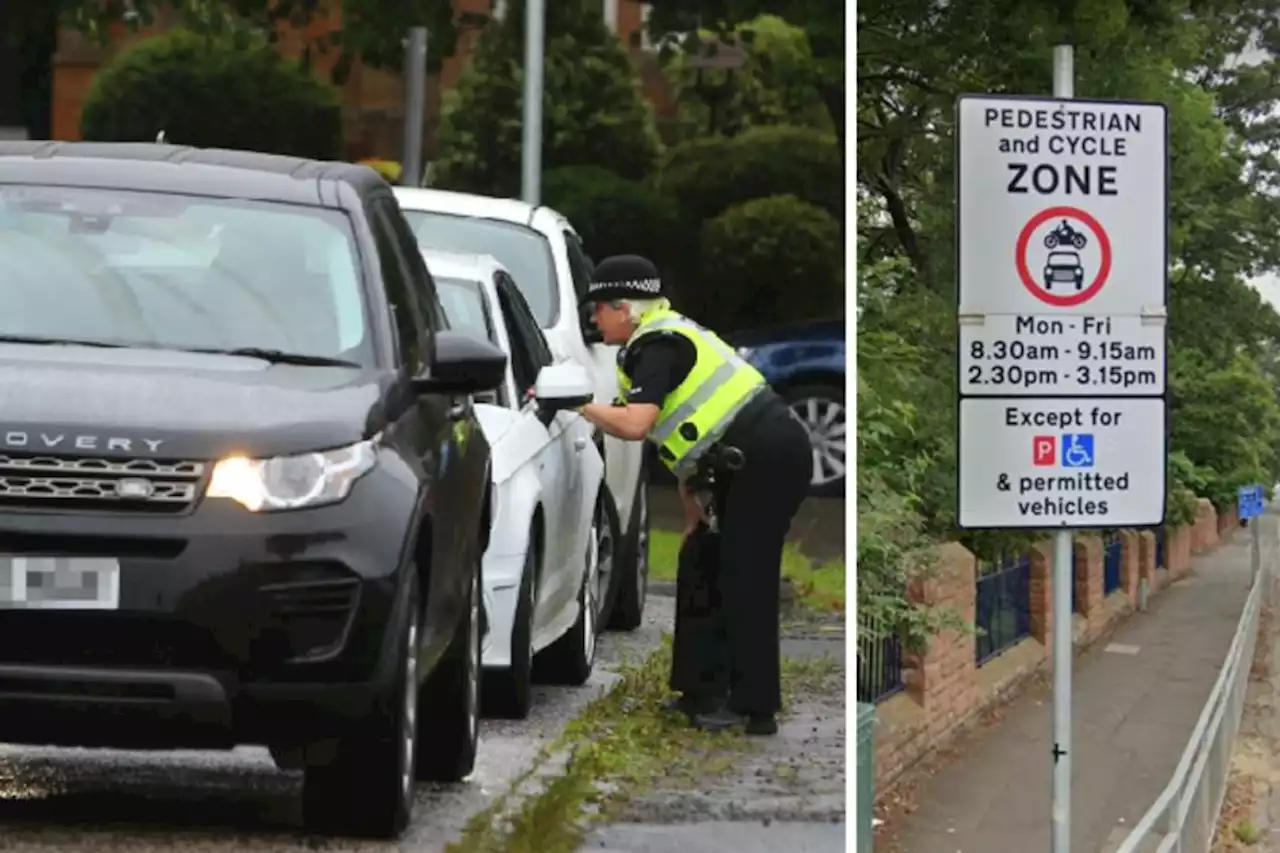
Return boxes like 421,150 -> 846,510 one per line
494,279 -> 577,624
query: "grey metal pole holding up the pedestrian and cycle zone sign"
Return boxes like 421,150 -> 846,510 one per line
1050,45 -> 1075,853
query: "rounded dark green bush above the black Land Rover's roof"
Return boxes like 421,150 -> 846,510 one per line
81,29 -> 342,160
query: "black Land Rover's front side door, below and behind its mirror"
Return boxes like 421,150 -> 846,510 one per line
372,199 -> 473,648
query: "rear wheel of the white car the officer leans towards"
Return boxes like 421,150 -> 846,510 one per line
535,487 -> 618,686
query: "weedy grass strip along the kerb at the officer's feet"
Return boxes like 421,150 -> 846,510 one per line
445,637 -> 838,853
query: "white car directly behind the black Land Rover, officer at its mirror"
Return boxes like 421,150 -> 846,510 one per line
422,251 -> 617,719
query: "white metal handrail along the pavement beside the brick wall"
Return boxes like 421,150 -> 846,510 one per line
1112,519 -> 1271,853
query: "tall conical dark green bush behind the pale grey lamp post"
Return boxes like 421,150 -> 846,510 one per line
433,0 -> 658,196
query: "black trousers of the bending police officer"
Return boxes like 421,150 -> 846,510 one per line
671,405 -> 813,715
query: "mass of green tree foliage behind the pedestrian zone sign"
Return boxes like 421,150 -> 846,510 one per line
849,0 -> 1280,637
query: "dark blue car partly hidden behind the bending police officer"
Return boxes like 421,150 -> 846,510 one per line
728,319 -> 846,497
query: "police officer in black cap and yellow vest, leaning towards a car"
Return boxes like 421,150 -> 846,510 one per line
582,255 -> 813,734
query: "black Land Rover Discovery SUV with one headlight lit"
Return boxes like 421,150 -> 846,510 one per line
0,142 -> 506,836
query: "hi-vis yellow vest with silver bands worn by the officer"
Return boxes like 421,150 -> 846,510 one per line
618,309 -> 767,476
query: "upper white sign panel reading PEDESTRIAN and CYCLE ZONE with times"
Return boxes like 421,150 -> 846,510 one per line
956,95 -> 1169,397
